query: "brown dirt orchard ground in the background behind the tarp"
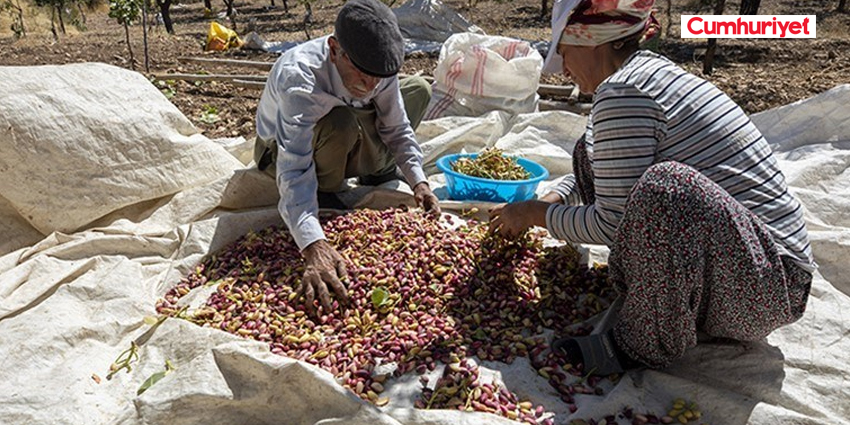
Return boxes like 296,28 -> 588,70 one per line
0,0 -> 850,138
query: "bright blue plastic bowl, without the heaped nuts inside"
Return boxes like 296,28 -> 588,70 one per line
437,153 -> 549,202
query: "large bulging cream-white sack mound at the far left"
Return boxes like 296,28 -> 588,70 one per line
0,64 -> 241,234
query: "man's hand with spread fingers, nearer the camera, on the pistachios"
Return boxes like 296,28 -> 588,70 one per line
297,239 -> 348,313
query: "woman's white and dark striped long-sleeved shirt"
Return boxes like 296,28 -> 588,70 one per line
546,51 -> 815,271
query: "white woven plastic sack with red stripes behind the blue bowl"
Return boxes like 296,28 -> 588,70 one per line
425,33 -> 543,119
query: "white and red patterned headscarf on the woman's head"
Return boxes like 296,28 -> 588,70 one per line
543,0 -> 660,74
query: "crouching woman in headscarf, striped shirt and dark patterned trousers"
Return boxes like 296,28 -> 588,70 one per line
490,0 -> 816,375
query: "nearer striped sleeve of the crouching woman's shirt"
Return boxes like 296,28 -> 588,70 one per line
546,84 -> 667,245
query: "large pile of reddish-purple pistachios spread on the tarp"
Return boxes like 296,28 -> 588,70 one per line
157,209 -> 612,422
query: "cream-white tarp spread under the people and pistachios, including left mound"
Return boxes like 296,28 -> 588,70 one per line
0,64 -> 850,425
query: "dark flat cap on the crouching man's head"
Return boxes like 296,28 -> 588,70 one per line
334,0 -> 404,78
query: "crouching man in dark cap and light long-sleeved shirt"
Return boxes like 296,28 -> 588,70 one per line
254,0 -> 439,311
